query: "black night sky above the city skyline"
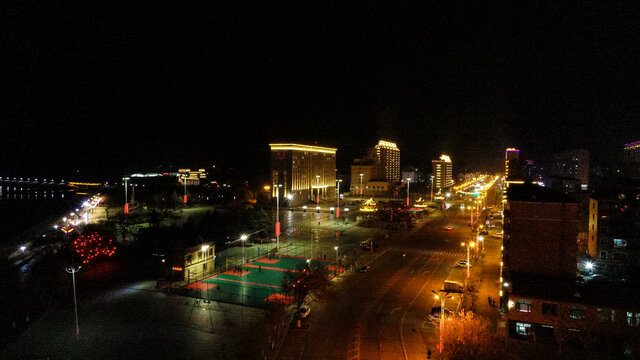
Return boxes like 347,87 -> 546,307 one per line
0,0 -> 640,176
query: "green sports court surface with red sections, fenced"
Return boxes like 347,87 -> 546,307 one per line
179,256 -> 344,307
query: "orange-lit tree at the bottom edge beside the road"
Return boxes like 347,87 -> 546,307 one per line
442,311 -> 513,360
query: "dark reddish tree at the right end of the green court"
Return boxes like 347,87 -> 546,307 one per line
282,263 -> 331,310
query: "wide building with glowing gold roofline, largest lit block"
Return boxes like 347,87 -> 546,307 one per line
269,143 -> 337,201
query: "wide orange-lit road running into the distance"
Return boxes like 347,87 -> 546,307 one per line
278,202 -> 480,359
